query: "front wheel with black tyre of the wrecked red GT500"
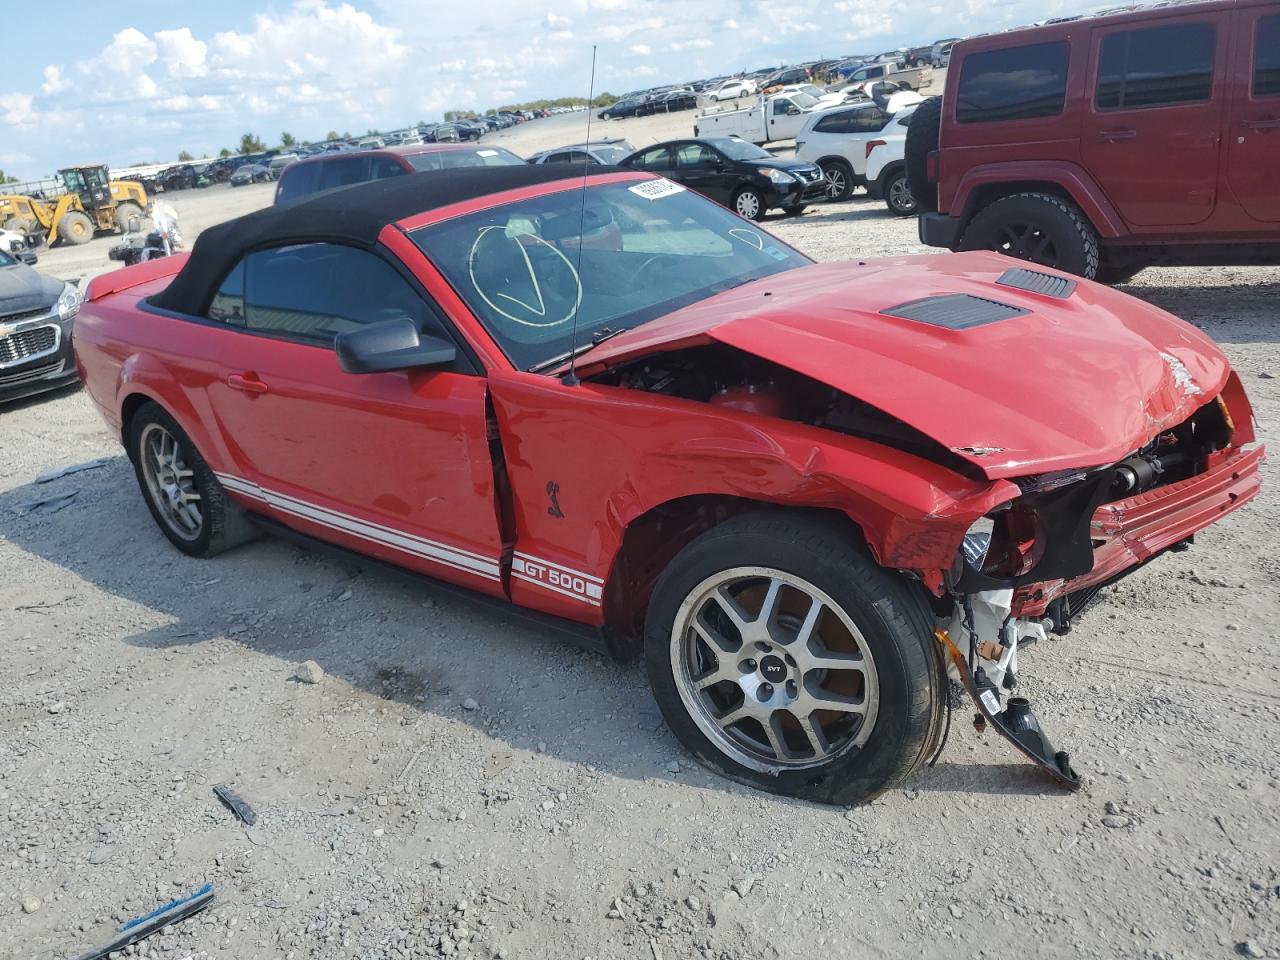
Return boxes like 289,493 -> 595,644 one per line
645,513 -> 946,804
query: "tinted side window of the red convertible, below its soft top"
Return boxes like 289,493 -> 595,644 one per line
229,243 -> 447,346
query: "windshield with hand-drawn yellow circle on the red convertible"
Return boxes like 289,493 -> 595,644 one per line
411,179 -> 812,370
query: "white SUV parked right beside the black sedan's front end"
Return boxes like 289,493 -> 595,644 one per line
796,91 -> 920,200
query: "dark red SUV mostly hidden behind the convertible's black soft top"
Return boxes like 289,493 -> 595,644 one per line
275,143 -> 525,204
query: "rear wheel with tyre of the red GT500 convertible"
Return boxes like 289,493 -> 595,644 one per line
128,403 -> 257,557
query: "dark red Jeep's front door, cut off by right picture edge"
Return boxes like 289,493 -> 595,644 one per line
1226,6 -> 1280,229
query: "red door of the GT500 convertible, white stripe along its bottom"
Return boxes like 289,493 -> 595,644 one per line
211,333 -> 503,595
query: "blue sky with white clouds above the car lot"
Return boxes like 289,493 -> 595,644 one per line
0,0 -> 1098,178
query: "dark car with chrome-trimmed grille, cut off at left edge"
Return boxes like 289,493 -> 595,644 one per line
0,251 -> 81,401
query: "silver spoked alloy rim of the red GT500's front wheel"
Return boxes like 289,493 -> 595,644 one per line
671,567 -> 879,773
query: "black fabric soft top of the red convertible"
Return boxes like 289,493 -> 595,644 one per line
151,164 -> 618,316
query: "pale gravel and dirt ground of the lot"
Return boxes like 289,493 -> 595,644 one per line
0,101 -> 1280,960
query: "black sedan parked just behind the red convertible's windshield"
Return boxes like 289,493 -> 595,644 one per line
622,137 -> 826,220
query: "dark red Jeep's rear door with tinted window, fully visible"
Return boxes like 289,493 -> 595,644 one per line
1080,13 -> 1230,233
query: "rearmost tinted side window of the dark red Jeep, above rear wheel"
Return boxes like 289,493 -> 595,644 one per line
956,41 -> 1071,123
